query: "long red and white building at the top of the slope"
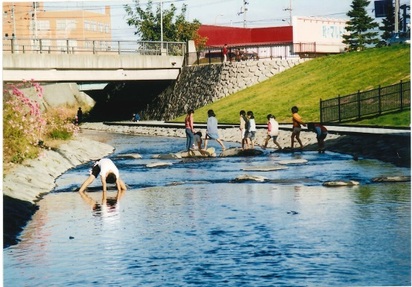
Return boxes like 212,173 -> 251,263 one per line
198,17 -> 346,59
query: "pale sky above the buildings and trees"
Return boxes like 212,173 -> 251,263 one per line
45,0 -> 409,40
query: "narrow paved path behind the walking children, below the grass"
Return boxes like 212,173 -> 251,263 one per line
105,121 -> 411,136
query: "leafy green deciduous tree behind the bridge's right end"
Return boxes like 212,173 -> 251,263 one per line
124,0 -> 207,47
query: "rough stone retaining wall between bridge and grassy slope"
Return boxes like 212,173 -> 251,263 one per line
144,59 -> 305,120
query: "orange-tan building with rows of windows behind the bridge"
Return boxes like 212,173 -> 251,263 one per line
3,2 -> 112,52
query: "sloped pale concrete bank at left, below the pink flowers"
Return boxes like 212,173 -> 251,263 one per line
3,136 -> 114,247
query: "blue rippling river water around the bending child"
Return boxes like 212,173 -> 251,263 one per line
3,134 -> 411,286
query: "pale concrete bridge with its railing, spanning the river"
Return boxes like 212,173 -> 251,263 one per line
3,39 -> 186,82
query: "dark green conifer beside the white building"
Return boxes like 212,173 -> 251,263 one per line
343,0 -> 379,51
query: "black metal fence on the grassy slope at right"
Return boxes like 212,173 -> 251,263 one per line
320,81 -> 411,123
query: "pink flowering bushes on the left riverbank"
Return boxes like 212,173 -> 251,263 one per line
3,81 -> 83,171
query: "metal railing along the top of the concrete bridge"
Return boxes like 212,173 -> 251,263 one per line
3,38 -> 186,56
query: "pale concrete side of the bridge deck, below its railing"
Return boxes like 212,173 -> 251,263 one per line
3,54 -> 184,82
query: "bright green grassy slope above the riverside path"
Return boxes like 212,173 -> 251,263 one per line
176,45 -> 410,126
